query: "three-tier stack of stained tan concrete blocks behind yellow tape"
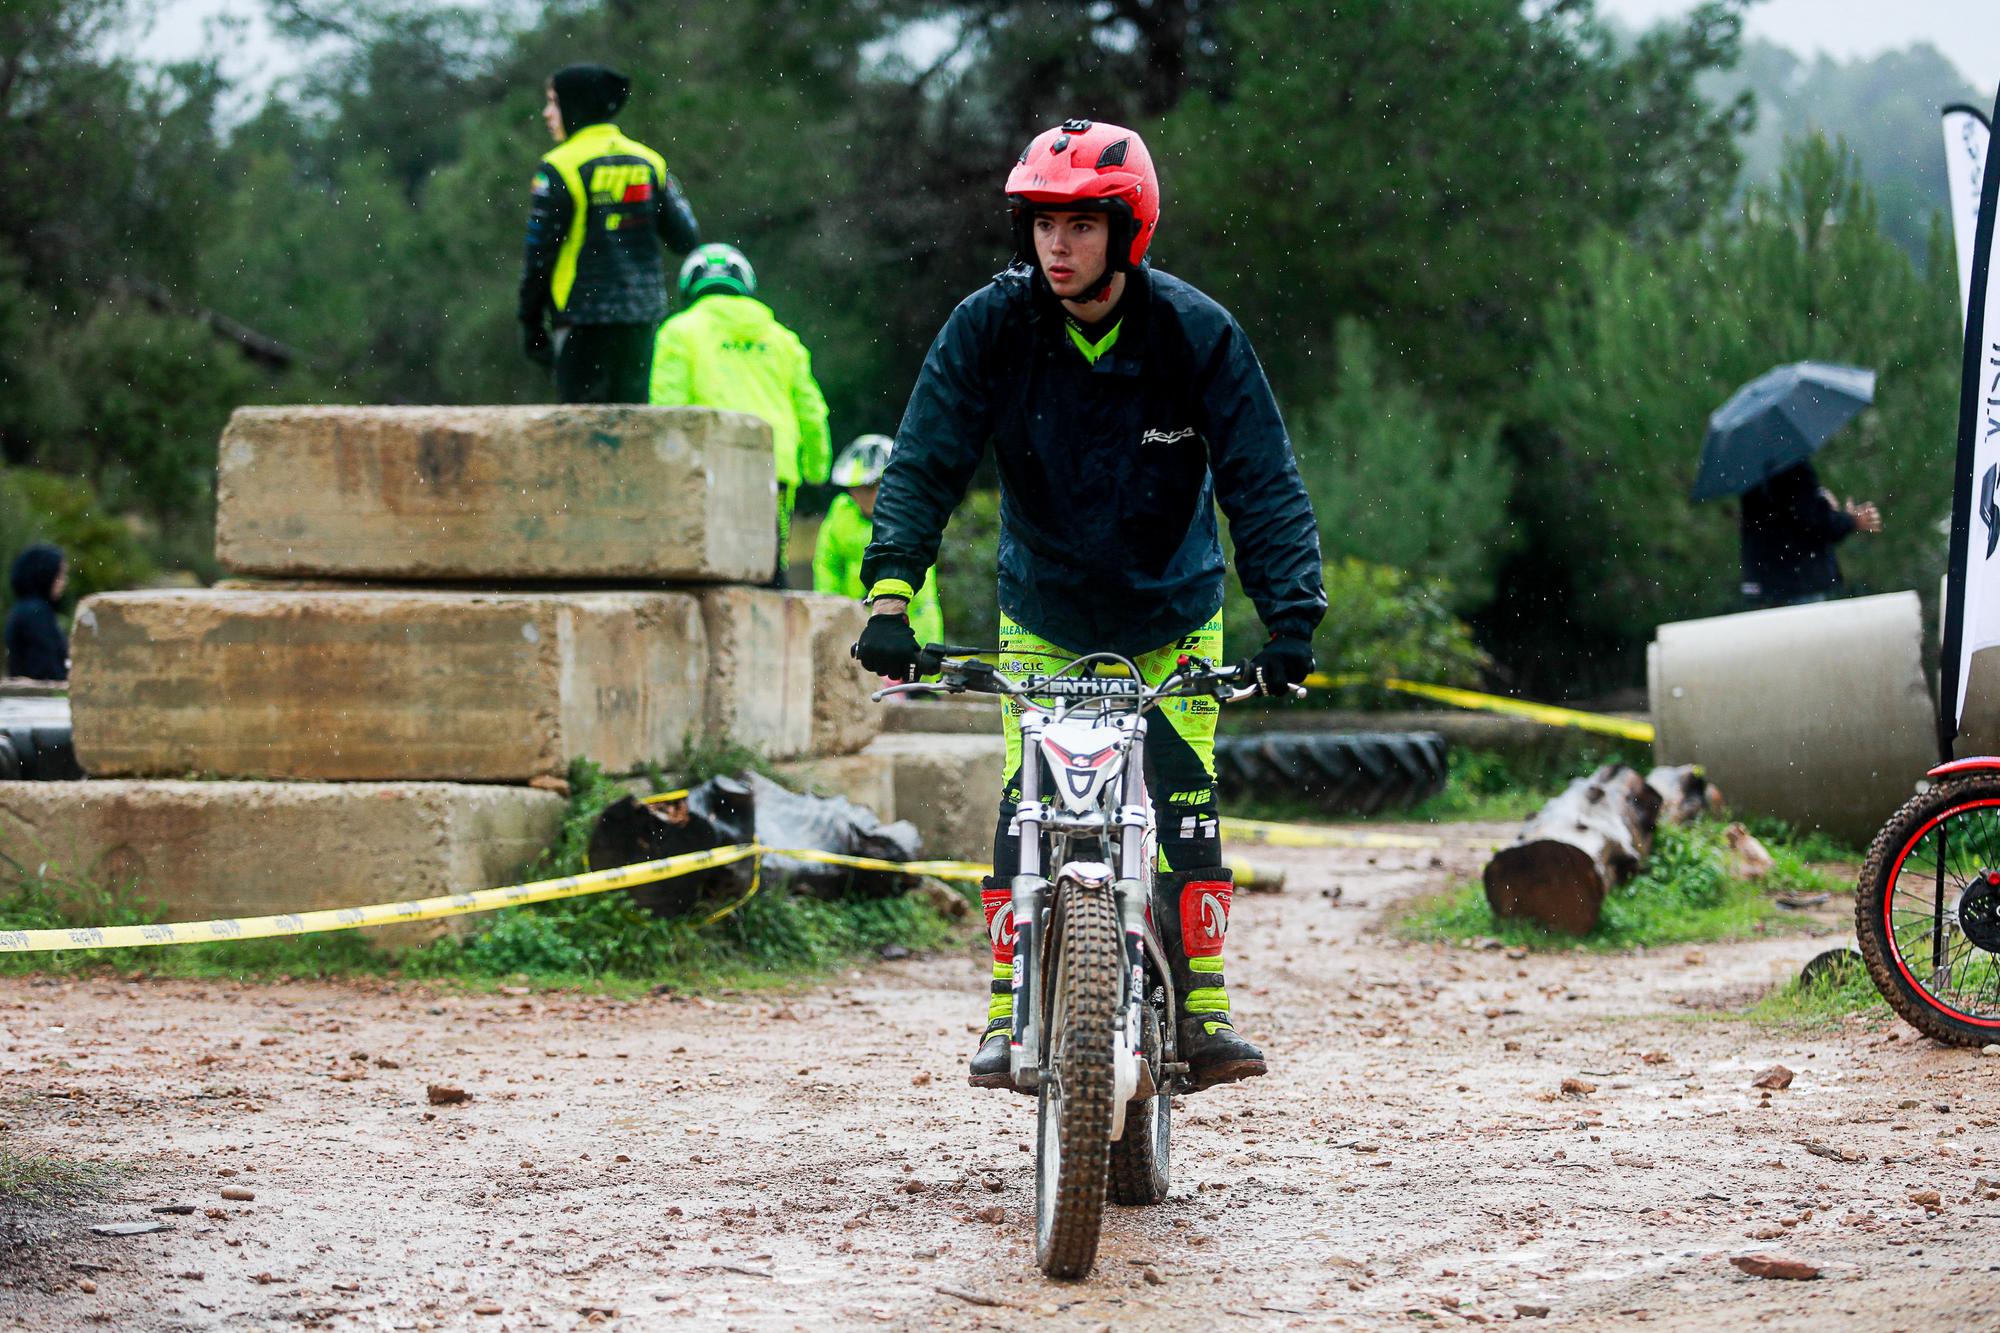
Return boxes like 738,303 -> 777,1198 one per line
50,406 -> 908,919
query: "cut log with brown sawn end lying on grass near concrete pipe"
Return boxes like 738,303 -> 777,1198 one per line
1484,765 -> 1662,935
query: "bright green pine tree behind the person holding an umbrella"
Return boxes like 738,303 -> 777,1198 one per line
1516,136 -> 1958,642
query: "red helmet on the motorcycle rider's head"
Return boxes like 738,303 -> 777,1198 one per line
1006,120 -> 1160,278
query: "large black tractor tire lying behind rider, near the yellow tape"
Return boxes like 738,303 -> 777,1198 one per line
1216,731 -> 1446,815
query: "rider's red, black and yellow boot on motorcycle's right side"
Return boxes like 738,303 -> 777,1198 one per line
1152,867 -> 1264,1093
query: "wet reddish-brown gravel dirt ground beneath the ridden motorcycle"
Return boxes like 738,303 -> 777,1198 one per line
0,825 -> 2000,1333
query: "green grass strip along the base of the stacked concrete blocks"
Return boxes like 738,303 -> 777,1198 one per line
0,751 -> 966,989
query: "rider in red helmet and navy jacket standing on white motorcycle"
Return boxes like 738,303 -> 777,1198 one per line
856,120 -> 1326,1089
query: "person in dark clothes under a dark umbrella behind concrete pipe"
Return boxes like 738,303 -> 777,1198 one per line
1690,360 -> 1882,608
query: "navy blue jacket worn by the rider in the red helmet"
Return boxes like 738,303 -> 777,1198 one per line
862,264 -> 1326,656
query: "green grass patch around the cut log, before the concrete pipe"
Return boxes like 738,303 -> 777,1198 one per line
1394,823 -> 1836,951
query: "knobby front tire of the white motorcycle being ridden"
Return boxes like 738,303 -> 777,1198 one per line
1034,883 -> 1124,1279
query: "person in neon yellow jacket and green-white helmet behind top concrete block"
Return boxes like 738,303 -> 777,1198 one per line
648,244 -> 832,586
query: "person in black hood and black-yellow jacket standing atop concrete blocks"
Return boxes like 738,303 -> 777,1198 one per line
518,64 -> 700,402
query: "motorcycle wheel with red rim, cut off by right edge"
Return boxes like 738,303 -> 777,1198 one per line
1854,773 -> 2000,1047
